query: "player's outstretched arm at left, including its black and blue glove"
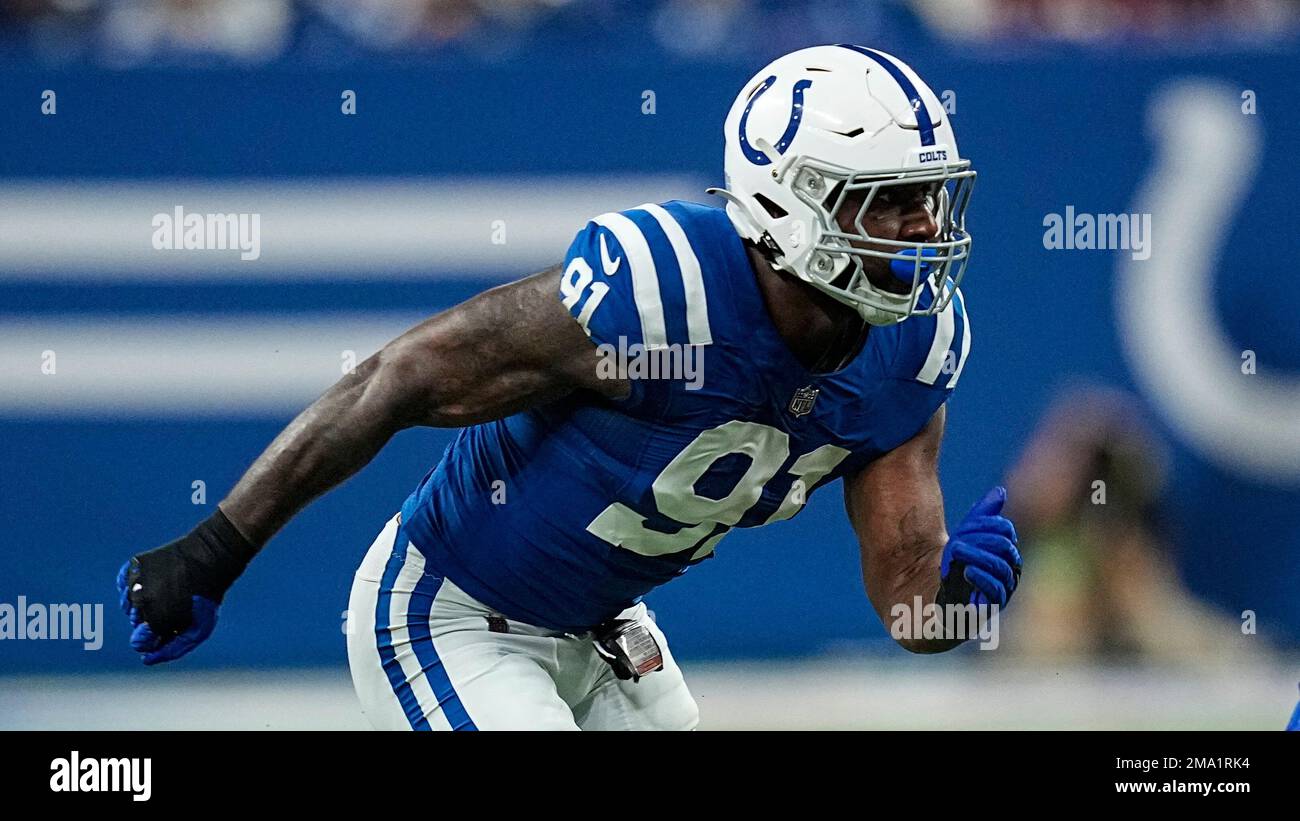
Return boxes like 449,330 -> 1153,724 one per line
120,268 -> 628,664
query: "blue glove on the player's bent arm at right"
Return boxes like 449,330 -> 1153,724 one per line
935,487 -> 1022,607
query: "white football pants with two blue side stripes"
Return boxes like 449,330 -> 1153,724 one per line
347,516 -> 699,730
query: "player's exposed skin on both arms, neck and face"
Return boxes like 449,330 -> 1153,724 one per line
220,183 -> 959,652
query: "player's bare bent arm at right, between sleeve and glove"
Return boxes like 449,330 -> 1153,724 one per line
844,407 -> 959,653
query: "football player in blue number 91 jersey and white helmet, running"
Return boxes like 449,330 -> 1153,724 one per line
118,45 -> 1021,730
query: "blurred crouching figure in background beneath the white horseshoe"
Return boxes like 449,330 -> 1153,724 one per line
1008,388 -> 1258,664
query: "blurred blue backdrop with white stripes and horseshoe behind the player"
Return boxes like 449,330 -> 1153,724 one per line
0,1 -> 1300,672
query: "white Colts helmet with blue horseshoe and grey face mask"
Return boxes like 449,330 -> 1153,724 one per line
710,45 -> 975,325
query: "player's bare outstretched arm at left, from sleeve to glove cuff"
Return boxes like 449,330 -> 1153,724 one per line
220,268 -> 628,547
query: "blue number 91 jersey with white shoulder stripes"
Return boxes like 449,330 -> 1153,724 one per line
402,201 -> 971,633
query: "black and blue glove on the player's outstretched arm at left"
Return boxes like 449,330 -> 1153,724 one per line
117,509 -> 257,665
